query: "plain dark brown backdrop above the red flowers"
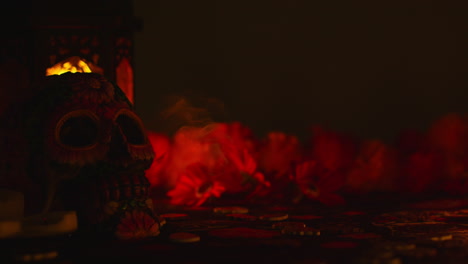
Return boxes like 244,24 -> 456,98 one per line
134,0 -> 468,142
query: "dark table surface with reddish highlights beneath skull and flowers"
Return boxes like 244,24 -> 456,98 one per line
0,199 -> 468,264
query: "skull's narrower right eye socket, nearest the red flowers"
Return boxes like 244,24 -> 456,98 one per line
115,110 -> 146,145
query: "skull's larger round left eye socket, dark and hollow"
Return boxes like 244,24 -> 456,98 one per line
56,111 -> 99,148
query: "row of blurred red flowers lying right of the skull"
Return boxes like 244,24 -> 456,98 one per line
146,114 -> 468,207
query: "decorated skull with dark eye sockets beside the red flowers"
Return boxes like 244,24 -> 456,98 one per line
2,73 -> 164,238
